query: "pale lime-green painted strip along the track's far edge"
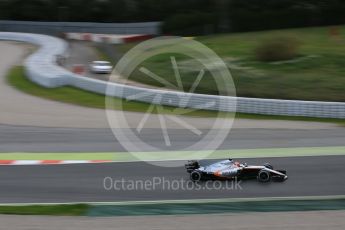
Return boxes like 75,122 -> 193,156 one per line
0,146 -> 345,162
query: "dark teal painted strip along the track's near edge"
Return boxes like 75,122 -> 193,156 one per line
87,199 -> 345,216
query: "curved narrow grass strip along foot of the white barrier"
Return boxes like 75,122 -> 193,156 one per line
7,66 -> 345,125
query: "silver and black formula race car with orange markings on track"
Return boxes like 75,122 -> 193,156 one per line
185,159 -> 288,183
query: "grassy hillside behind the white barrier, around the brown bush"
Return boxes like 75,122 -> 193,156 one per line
117,26 -> 345,101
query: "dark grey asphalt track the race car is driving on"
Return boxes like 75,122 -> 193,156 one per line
0,156 -> 345,203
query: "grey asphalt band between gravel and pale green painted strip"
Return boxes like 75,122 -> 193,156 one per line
0,125 -> 345,152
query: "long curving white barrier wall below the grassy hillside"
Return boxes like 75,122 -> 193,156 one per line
0,32 -> 345,118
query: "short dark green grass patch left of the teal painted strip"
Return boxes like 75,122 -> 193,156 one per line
0,204 -> 90,216
